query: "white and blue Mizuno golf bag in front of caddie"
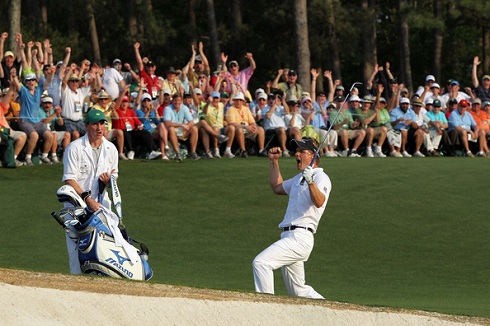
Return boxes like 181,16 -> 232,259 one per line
51,185 -> 153,281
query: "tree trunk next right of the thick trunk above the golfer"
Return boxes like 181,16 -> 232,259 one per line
360,0 -> 378,90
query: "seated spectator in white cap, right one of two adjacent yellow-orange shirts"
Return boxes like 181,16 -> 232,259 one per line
225,92 -> 267,158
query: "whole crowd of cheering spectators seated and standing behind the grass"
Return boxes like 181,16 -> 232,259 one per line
0,32 -> 490,166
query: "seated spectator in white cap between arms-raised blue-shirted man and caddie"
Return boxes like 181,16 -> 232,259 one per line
39,96 -> 71,163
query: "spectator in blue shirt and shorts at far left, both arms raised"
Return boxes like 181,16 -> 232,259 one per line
11,71 -> 53,165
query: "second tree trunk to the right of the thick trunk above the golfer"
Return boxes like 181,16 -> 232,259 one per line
398,0 -> 413,94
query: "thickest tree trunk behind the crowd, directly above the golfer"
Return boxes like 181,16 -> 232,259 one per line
293,0 -> 311,90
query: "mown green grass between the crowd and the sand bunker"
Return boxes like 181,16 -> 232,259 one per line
0,157 -> 490,317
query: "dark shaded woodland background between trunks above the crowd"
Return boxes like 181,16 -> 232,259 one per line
0,0 -> 490,93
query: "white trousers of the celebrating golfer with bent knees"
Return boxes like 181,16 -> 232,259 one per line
252,228 -> 324,299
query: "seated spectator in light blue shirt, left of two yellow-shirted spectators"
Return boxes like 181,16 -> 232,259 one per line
163,93 -> 199,162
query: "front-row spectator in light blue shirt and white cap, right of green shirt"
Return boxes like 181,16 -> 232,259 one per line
390,97 -> 419,157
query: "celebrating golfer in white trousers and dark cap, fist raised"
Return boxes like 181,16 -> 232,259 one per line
252,137 -> 332,299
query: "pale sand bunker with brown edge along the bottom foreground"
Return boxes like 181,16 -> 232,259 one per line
0,269 -> 490,326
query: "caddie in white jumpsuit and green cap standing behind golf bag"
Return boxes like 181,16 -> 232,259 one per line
62,110 -> 118,274
